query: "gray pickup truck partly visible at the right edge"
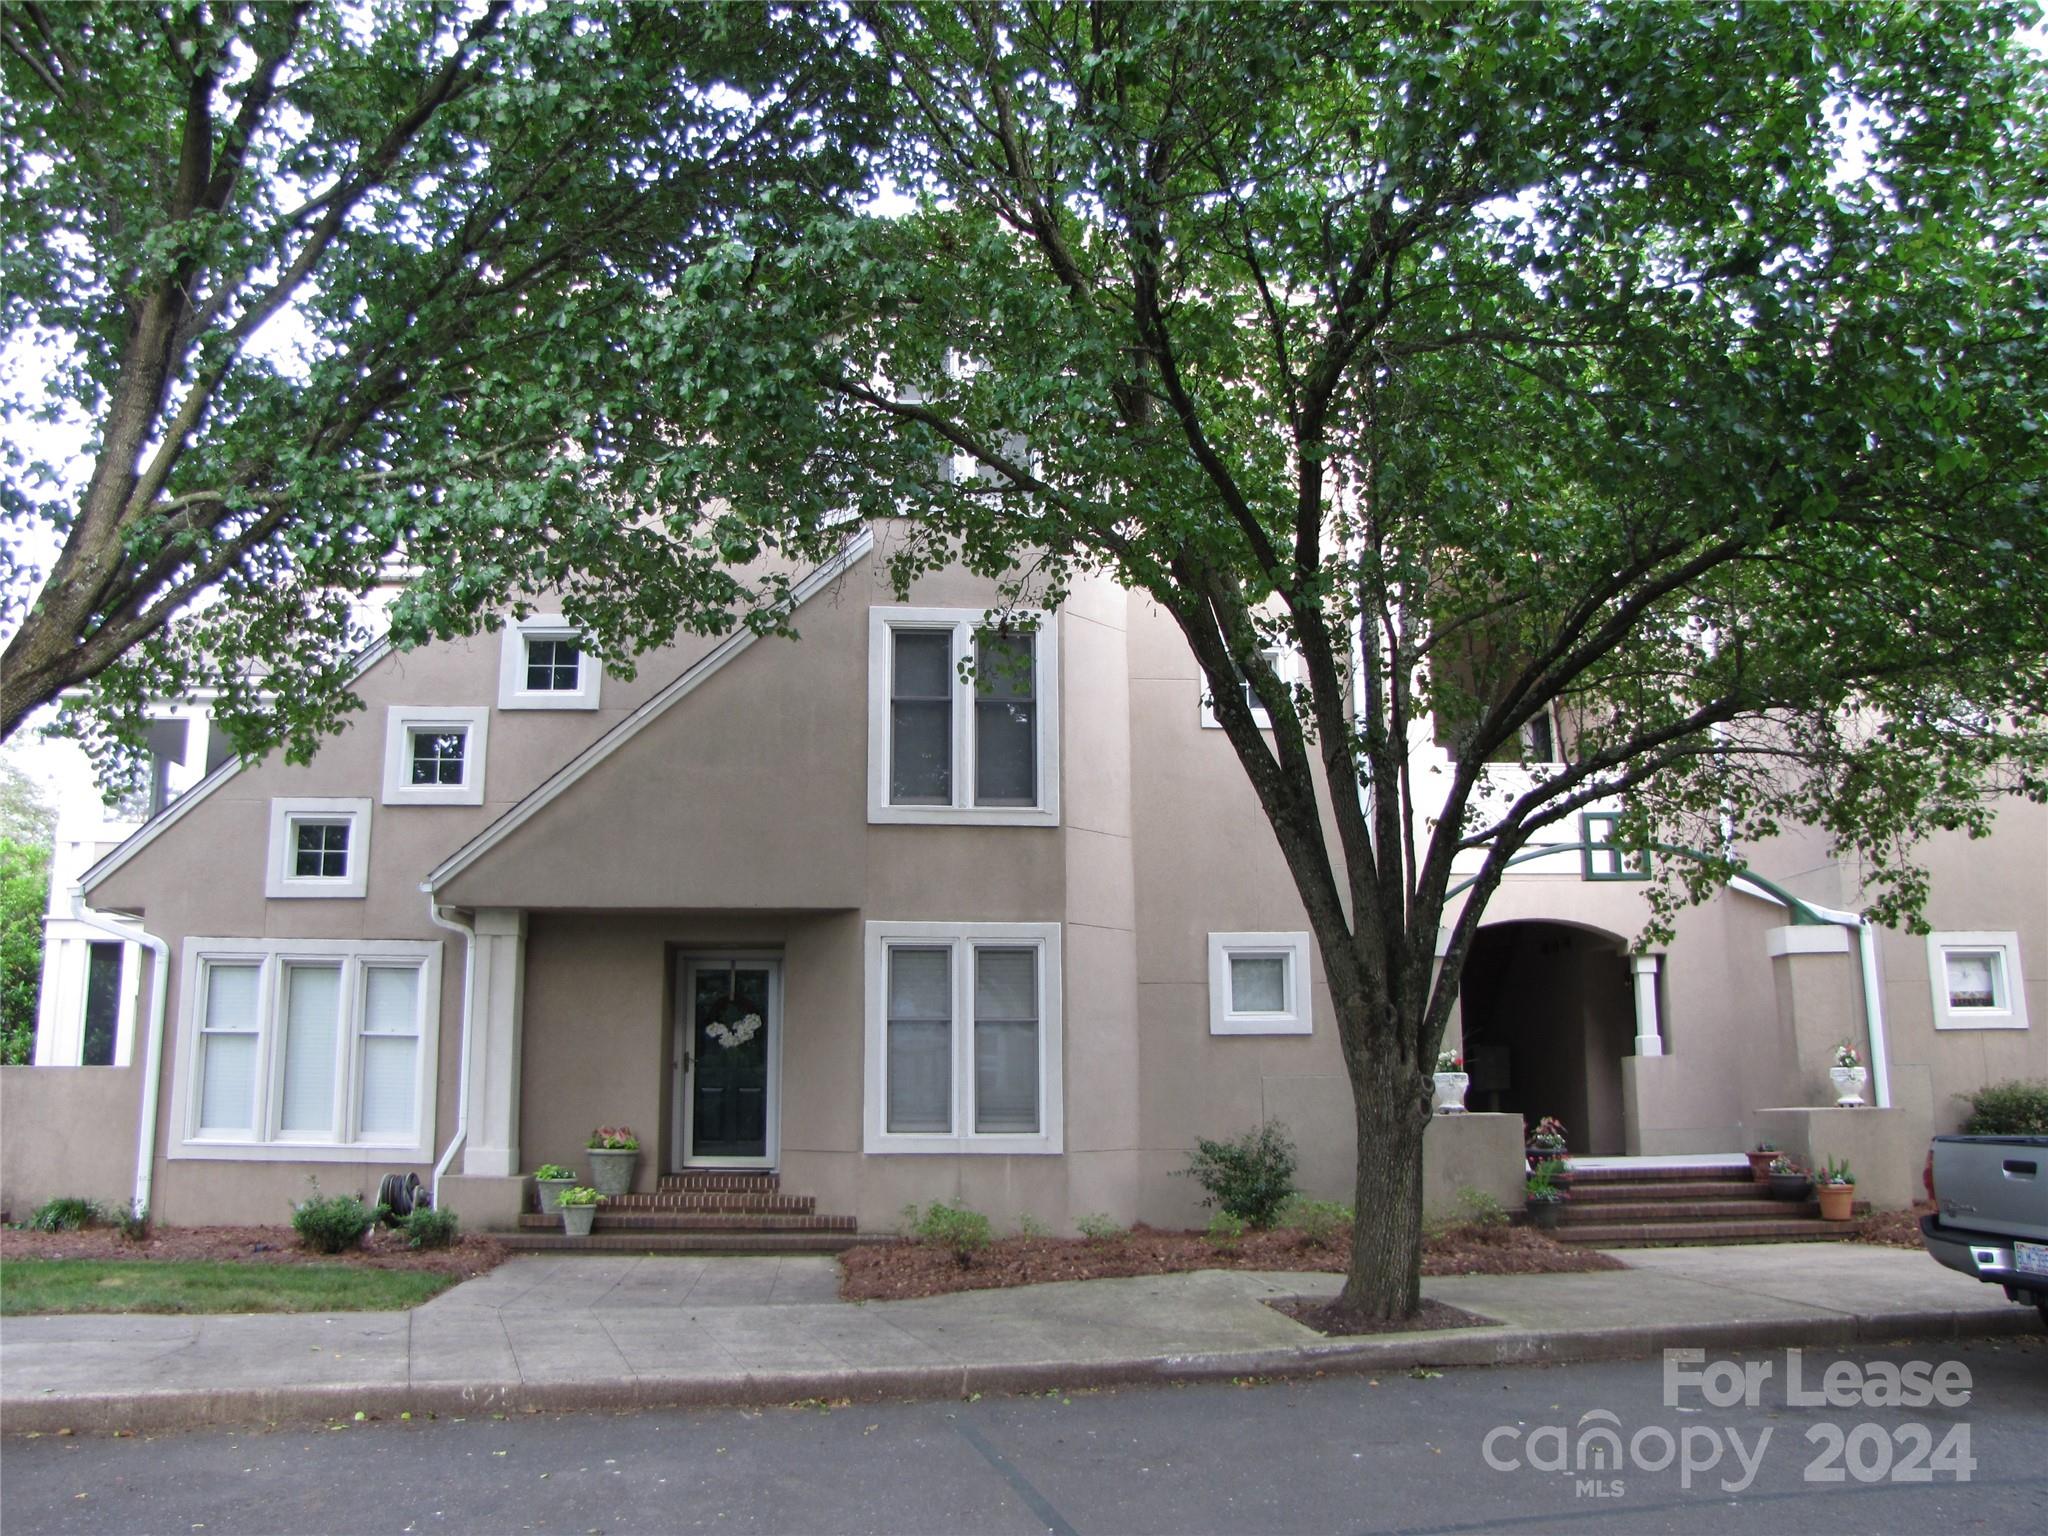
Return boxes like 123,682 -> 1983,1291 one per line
1921,1137 -> 2048,1323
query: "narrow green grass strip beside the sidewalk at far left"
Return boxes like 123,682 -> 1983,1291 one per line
0,1260 -> 461,1317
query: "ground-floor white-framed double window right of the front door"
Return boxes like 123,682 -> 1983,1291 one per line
862,922 -> 1065,1153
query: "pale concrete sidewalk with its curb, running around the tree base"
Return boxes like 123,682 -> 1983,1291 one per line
0,1243 -> 2040,1434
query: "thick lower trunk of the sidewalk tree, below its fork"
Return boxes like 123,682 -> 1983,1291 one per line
1337,1049 -> 1430,1321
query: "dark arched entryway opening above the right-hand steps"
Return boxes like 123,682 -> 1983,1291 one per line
1458,922 -> 1636,1157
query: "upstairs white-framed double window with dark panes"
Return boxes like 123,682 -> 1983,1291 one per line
868,608 -> 1059,827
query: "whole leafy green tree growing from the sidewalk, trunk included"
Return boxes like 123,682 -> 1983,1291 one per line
645,4 -> 2048,1315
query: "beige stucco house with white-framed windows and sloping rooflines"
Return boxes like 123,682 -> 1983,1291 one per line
0,530 -> 2048,1229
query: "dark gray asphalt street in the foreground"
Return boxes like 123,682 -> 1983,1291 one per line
0,1335 -> 2048,1536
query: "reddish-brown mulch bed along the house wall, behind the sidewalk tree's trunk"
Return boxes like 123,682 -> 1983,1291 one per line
840,1227 -> 1626,1300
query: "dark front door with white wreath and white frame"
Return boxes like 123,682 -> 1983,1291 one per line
676,954 -> 782,1167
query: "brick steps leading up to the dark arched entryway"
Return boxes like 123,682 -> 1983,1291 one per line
1552,1165 -> 1870,1247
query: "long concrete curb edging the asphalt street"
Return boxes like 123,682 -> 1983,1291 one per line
12,1307 -> 2038,1436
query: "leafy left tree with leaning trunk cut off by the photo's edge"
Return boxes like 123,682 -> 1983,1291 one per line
0,0 -> 870,770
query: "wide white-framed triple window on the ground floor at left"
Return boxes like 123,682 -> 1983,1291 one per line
170,938 -> 440,1161
